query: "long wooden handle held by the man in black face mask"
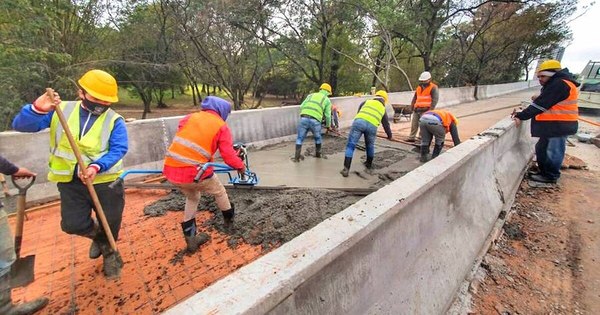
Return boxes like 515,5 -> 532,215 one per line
46,89 -> 117,252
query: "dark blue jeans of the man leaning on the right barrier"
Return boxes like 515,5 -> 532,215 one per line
535,137 -> 567,179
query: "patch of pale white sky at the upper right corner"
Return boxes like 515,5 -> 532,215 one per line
561,0 -> 600,73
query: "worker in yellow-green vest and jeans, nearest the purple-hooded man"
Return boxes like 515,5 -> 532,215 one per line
293,83 -> 331,162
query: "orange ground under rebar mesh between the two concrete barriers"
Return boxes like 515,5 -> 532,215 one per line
9,189 -> 264,314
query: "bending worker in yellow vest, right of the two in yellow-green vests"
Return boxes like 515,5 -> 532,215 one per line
340,90 -> 392,177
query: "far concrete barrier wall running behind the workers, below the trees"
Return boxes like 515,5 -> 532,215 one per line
0,82 -> 530,206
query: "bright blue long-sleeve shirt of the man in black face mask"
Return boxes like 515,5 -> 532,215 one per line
12,104 -> 129,172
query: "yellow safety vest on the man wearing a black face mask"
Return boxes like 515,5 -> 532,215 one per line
48,101 -> 123,184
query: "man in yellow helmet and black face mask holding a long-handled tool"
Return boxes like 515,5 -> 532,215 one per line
13,69 -> 128,278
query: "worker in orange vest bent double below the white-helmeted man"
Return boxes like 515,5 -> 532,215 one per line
419,109 -> 460,162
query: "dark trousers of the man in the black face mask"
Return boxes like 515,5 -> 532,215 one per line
58,177 -> 125,240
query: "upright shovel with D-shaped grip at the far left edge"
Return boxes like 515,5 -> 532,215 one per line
10,176 -> 35,288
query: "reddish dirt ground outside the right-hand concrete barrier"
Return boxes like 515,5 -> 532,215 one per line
470,169 -> 600,315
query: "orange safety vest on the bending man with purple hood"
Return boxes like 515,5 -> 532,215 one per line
165,111 -> 225,167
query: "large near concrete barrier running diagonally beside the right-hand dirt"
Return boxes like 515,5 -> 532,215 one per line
166,119 -> 532,314
